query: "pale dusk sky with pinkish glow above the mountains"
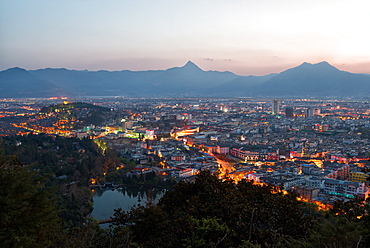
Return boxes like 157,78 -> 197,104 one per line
0,0 -> 370,75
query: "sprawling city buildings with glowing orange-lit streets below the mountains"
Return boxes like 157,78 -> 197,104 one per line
0,97 -> 370,205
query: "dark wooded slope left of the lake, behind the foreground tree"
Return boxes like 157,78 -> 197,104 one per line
0,134 -> 122,234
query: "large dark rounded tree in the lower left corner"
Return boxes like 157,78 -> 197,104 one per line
0,156 -> 60,247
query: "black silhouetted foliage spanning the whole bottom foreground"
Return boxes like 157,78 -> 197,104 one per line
0,160 -> 370,248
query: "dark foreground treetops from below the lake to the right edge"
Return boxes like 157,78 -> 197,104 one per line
114,172 -> 369,247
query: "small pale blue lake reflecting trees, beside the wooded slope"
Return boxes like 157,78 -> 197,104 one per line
91,188 -> 165,220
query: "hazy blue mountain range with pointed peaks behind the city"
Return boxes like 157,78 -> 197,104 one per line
0,61 -> 370,98
